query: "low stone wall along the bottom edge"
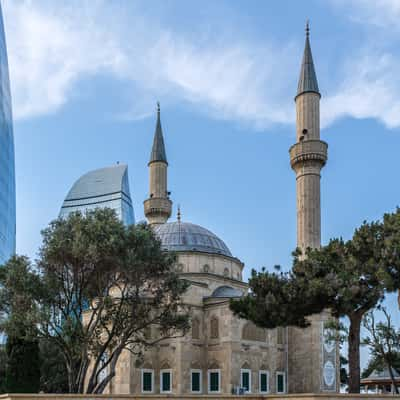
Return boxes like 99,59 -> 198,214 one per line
0,393 -> 400,400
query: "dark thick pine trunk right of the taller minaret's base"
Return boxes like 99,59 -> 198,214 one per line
348,314 -> 362,393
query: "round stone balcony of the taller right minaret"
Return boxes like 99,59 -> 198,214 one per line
289,140 -> 328,168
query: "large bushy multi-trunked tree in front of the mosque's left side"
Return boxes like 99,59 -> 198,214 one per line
34,209 -> 188,393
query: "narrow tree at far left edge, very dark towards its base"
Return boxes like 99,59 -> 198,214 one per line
0,257 -> 40,393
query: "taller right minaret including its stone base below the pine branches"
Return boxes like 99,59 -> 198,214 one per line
288,23 -> 340,393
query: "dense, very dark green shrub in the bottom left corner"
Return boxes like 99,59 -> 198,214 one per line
5,336 -> 40,393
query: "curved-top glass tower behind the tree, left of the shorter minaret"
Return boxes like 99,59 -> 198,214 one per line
60,164 -> 135,225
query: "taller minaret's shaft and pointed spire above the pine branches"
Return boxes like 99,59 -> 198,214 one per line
289,22 -> 328,254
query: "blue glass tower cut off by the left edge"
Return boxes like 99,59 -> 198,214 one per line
0,5 -> 15,264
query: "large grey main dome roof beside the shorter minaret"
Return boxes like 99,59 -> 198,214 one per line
154,222 -> 232,257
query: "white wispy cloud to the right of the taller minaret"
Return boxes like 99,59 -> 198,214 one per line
322,0 -> 400,128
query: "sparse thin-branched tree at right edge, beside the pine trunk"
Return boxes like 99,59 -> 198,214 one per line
363,307 -> 400,394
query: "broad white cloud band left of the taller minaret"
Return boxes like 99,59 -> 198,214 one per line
4,0 -> 297,126
